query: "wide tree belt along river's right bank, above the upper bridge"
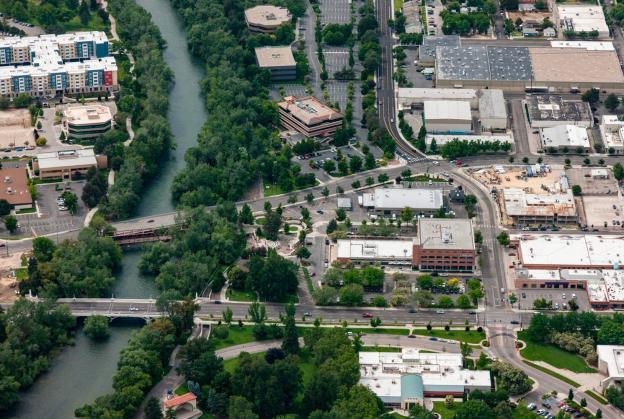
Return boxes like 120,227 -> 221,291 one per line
172,0 -> 314,206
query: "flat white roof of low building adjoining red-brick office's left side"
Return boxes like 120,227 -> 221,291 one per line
337,239 -> 413,262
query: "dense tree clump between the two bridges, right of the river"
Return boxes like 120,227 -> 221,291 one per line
139,207 -> 245,298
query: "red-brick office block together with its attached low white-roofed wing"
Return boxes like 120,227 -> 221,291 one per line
335,218 -> 476,272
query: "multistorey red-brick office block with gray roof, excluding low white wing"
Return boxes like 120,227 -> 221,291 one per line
412,218 -> 476,272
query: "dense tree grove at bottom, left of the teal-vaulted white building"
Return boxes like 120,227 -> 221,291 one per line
180,328 -> 382,419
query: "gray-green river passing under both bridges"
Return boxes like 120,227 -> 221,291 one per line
13,0 -> 206,419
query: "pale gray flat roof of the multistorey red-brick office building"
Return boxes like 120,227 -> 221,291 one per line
416,218 -> 475,250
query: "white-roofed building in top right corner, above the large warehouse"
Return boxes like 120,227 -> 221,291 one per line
553,4 -> 609,39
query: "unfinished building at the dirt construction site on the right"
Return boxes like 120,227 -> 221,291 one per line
501,188 -> 578,226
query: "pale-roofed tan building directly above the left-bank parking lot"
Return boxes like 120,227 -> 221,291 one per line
33,148 -> 107,180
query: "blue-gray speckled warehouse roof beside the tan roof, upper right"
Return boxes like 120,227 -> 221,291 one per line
436,45 -> 533,80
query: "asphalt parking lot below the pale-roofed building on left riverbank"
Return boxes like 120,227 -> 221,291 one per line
18,182 -> 88,240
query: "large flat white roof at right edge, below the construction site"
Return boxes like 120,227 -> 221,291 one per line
513,234 -> 624,268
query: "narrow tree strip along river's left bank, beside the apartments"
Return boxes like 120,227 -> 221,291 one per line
101,0 -> 173,218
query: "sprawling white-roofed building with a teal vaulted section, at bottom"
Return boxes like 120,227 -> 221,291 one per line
359,348 -> 492,410
